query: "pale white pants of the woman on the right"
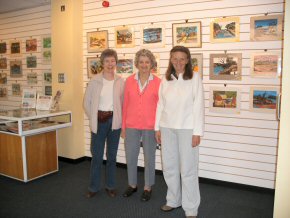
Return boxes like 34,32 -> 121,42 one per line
161,128 -> 200,216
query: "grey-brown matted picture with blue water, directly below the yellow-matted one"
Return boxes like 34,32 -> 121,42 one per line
209,53 -> 242,80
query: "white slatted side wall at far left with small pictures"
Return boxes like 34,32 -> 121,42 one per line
0,5 -> 52,110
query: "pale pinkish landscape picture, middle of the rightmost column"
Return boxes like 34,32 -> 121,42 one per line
251,52 -> 281,78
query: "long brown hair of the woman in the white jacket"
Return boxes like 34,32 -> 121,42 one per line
165,45 -> 193,81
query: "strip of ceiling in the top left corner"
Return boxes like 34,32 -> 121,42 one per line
0,0 -> 50,14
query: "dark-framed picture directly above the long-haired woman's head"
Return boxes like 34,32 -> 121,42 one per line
172,21 -> 202,48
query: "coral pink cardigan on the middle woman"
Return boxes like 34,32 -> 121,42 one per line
122,74 -> 161,130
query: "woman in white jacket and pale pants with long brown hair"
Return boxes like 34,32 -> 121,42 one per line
155,46 -> 204,217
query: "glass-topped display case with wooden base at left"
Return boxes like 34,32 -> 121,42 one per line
0,109 -> 72,182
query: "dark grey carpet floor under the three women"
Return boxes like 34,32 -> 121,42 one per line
0,161 -> 274,218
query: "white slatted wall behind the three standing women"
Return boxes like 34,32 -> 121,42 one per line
83,0 -> 284,188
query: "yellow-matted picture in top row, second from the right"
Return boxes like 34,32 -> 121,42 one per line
210,17 -> 240,43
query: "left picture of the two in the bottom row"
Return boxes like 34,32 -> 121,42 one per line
209,87 -> 241,114
